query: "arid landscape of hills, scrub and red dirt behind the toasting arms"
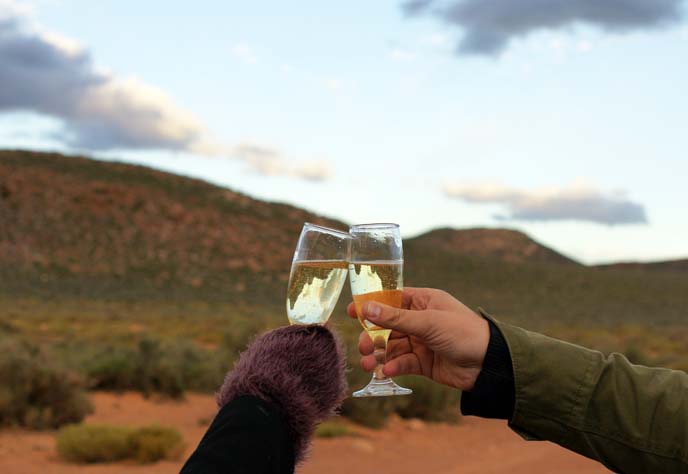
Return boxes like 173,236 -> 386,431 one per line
0,151 -> 688,474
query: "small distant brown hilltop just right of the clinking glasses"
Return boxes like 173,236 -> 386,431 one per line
410,228 -> 578,264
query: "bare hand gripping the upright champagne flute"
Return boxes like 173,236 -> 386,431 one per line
347,288 -> 490,390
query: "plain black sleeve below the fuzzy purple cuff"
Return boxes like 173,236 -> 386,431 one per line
181,396 -> 295,474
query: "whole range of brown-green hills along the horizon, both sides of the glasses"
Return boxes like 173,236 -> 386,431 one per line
0,151 -> 688,327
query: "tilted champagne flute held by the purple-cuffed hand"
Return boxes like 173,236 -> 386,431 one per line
287,222 -> 351,324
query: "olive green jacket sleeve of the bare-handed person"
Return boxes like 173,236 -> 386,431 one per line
494,321 -> 688,473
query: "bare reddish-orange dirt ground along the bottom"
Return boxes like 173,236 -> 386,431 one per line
0,393 -> 609,474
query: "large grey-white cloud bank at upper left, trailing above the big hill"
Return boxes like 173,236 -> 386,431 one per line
0,7 -> 329,180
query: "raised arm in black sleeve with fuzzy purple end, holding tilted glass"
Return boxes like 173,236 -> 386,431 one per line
182,325 -> 346,474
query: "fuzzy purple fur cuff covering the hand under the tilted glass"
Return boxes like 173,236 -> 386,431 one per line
217,325 -> 347,463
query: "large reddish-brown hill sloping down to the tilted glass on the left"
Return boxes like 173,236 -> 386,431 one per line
0,151 -> 347,299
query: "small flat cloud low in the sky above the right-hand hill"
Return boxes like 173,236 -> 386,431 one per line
444,183 -> 647,225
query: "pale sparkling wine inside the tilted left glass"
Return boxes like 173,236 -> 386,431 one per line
287,260 -> 347,324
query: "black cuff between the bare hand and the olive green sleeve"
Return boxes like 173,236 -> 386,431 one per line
461,319 -> 515,420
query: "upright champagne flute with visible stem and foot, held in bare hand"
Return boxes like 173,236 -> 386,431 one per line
349,224 -> 413,397
